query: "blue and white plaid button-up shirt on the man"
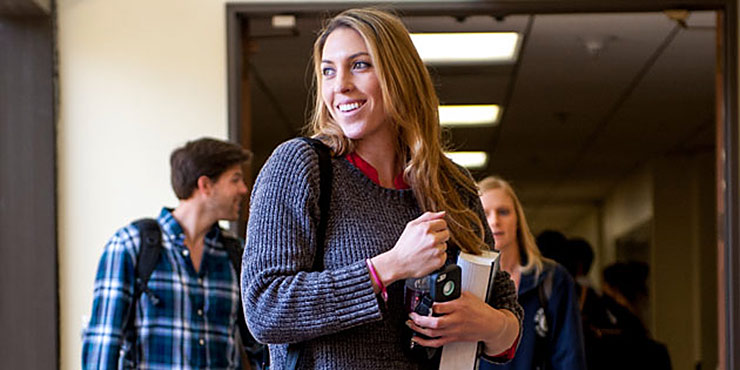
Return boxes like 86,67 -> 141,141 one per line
82,209 -> 242,369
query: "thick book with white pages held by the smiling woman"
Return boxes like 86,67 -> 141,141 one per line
439,251 -> 498,370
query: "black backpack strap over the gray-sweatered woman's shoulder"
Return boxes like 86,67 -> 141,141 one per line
285,137 -> 333,370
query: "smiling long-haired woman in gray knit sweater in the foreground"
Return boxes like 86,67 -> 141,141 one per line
242,9 -> 521,369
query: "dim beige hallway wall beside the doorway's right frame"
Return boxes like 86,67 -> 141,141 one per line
650,153 -> 717,369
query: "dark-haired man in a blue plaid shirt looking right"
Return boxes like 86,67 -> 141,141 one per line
82,138 -> 251,369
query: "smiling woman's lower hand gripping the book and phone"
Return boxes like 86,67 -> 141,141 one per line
406,292 -> 519,356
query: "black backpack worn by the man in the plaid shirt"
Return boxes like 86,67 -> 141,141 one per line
124,218 -> 270,369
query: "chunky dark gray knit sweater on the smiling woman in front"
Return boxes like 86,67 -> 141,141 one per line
242,139 -> 522,370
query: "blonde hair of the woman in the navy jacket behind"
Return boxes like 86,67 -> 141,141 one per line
478,176 -> 542,275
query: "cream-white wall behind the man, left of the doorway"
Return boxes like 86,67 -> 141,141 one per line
58,0 -> 227,369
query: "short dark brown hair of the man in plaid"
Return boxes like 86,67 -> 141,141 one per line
170,138 -> 252,200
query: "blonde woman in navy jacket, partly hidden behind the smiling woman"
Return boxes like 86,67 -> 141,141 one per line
478,176 -> 586,370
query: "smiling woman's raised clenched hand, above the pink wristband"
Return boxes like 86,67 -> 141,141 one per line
371,211 -> 450,286
